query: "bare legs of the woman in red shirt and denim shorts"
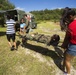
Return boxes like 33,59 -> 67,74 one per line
63,53 -> 73,74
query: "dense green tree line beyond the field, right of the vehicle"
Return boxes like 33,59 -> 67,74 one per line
30,8 -> 76,22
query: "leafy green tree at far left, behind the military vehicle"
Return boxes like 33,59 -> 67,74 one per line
0,0 -> 15,26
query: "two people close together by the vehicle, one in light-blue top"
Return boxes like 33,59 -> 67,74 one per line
19,14 -> 31,36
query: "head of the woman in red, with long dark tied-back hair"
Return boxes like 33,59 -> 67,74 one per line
60,7 -> 75,30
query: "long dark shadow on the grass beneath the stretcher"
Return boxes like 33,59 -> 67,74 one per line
25,43 -> 63,70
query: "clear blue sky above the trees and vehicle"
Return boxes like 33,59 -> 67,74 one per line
9,0 -> 76,12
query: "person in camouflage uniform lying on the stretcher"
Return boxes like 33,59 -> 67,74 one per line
23,33 -> 60,45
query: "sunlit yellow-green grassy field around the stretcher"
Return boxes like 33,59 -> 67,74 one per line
0,22 -> 75,75
